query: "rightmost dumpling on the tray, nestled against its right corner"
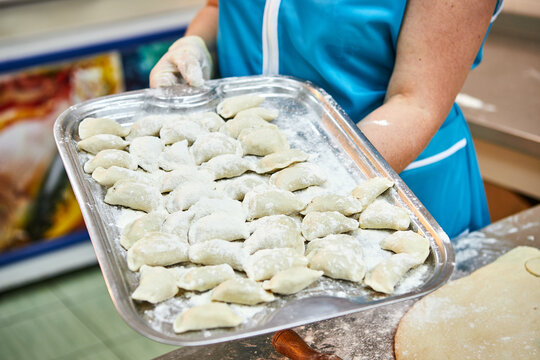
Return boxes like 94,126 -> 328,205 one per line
381,230 -> 429,264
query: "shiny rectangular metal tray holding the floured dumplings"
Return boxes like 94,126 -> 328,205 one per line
54,76 -> 454,346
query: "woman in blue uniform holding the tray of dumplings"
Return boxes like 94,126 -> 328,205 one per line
150,0 -> 500,238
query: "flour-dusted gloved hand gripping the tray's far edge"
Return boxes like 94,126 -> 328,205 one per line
150,36 -> 213,88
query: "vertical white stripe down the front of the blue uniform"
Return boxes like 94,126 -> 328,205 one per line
262,0 -> 281,75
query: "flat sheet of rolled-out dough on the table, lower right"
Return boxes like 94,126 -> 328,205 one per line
394,246 -> 540,360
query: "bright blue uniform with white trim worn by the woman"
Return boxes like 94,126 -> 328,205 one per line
217,0 -> 489,242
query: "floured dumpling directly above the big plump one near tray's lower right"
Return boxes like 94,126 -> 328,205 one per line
302,211 -> 358,241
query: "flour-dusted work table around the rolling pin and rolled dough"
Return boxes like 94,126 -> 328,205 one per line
159,206 -> 540,360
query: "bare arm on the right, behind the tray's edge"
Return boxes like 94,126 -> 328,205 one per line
358,0 -> 496,172
